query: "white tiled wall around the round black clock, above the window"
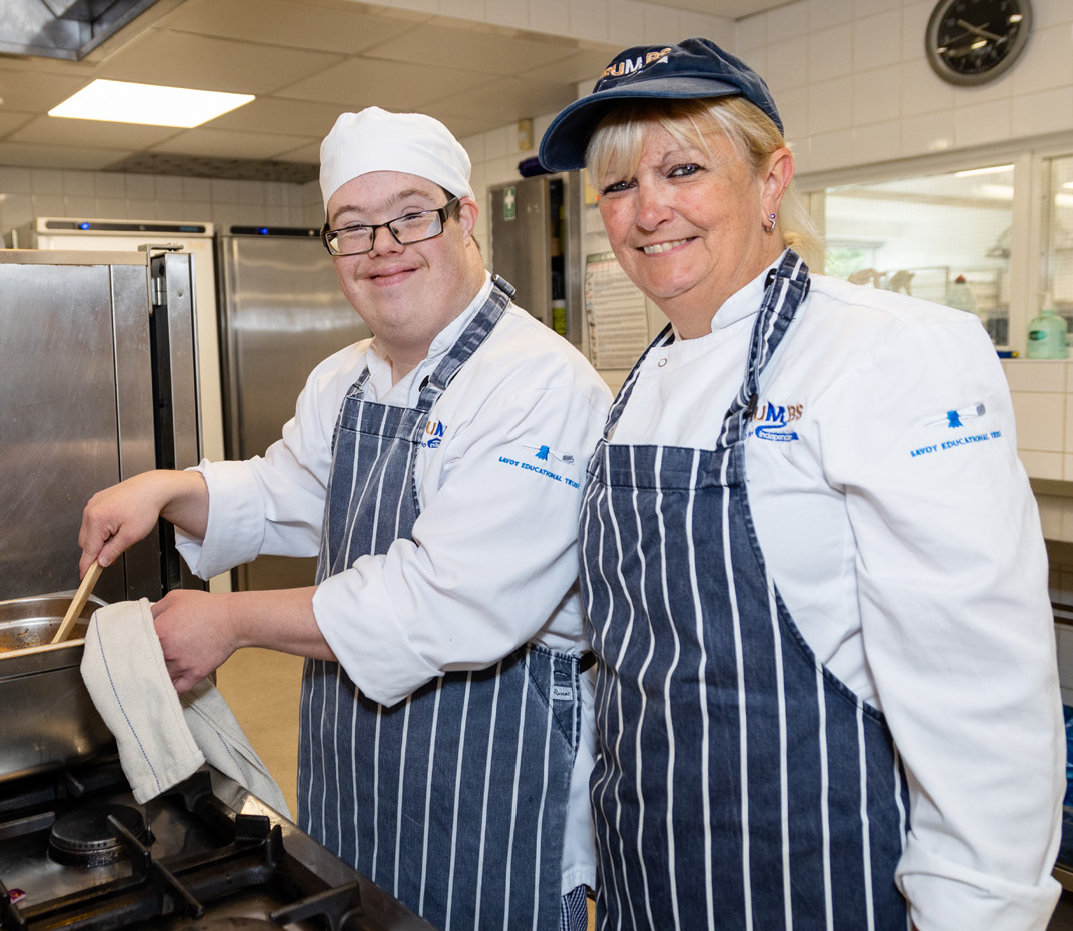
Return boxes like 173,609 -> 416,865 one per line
736,0 -> 1073,174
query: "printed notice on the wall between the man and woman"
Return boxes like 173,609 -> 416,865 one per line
585,252 -> 649,369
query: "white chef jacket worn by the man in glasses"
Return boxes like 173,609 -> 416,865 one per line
179,276 -> 611,892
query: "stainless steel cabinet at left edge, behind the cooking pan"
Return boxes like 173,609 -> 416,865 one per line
0,249 -> 201,602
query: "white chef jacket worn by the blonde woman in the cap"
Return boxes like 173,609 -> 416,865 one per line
613,258 -> 1064,931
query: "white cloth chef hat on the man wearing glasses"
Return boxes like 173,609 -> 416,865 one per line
321,106 -> 473,210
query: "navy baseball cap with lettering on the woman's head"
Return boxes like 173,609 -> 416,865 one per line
540,39 -> 782,172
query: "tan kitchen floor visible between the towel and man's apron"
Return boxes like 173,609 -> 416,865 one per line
217,648 -> 600,931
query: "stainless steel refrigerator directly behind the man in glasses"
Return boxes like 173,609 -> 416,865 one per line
216,226 -> 370,590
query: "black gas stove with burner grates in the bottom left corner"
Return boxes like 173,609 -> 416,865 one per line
0,757 -> 431,931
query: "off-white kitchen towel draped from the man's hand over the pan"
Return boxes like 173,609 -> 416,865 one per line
82,599 -> 291,817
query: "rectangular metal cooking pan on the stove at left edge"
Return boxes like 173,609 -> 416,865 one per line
0,592 -> 114,781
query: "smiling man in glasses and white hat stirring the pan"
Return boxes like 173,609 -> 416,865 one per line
79,107 -> 609,928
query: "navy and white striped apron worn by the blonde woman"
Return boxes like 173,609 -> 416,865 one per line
582,252 -> 908,931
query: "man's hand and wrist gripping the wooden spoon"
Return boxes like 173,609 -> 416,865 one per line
78,470 -> 208,576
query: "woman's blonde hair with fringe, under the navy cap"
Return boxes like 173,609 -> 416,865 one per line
585,97 -> 823,268
